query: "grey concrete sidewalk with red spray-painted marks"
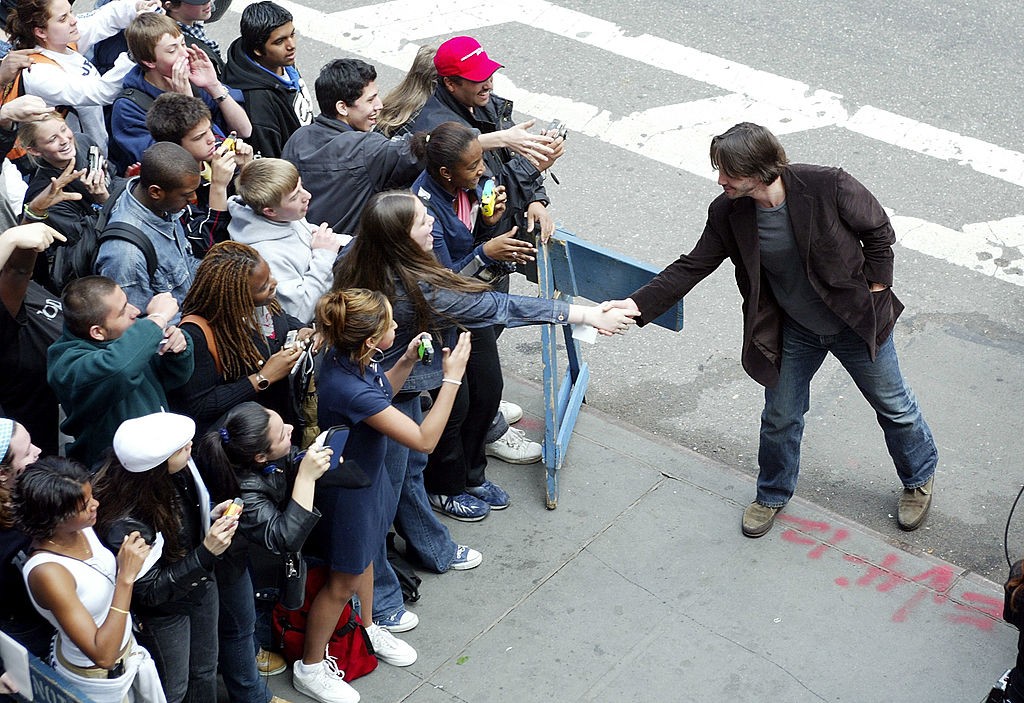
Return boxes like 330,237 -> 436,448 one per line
269,379 -> 1017,703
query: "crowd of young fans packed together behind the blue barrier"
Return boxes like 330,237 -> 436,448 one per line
0,0 -> 629,703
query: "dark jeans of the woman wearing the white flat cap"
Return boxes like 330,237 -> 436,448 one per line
138,579 -> 217,703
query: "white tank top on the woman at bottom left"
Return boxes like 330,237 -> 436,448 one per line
22,527 -> 131,667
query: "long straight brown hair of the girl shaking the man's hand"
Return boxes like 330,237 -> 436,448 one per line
331,190 -> 490,337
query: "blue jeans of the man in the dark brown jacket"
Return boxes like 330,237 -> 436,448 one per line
757,320 -> 938,508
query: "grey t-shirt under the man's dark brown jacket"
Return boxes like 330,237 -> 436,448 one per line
758,203 -> 846,335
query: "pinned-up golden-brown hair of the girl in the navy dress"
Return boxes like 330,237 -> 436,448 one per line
316,288 -> 391,370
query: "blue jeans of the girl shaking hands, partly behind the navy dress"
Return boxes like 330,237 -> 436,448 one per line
374,395 -> 458,619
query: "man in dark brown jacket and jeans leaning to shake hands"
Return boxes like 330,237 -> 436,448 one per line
611,123 -> 938,537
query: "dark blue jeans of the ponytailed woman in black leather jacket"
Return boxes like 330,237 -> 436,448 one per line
217,571 -> 272,703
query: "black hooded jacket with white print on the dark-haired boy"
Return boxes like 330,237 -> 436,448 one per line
224,39 -> 313,159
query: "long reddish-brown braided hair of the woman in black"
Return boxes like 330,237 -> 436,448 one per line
181,241 -> 282,380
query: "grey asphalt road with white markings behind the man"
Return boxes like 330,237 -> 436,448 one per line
199,0 -> 1024,580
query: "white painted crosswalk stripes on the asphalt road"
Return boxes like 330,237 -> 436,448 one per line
231,0 -> 1024,285
